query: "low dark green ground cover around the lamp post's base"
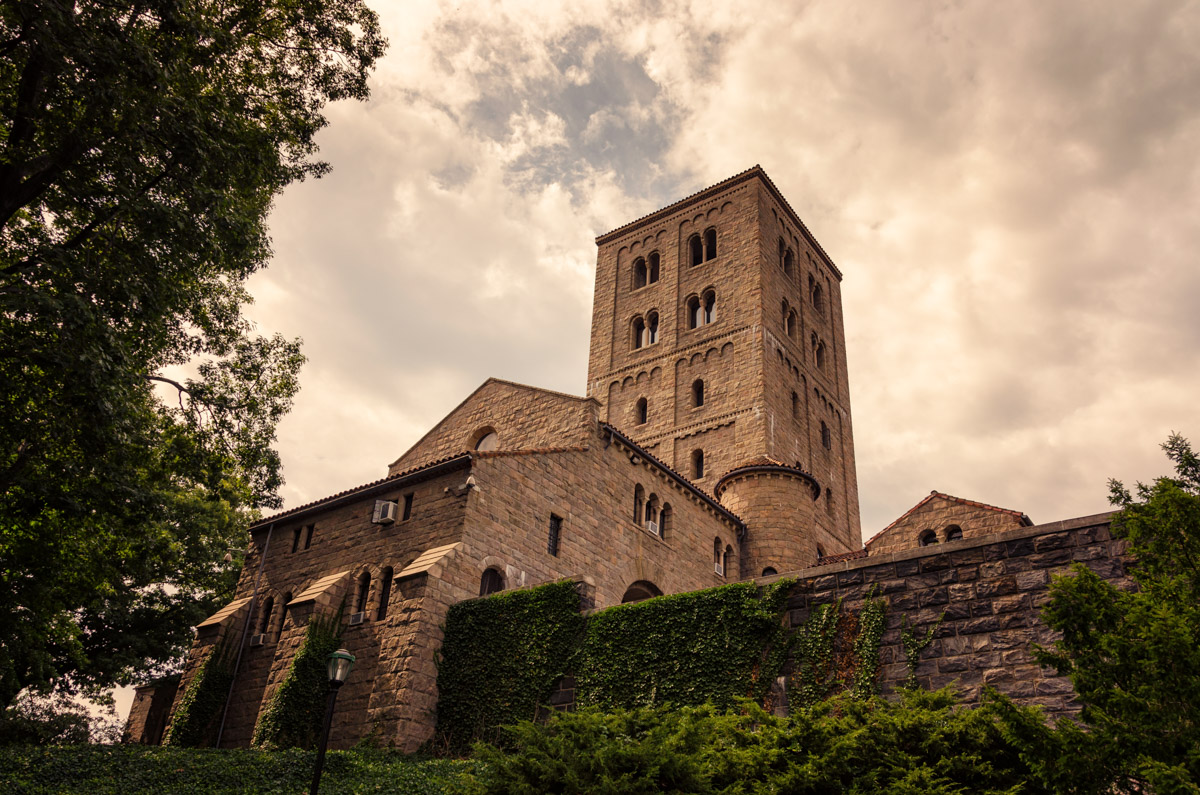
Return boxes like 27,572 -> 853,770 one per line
0,746 -> 475,795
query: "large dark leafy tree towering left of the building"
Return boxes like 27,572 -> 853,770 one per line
0,0 -> 386,704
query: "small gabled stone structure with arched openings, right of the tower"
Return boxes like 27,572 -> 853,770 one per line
866,491 -> 1033,555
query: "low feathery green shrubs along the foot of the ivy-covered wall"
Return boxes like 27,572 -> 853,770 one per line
454,691 -> 1058,795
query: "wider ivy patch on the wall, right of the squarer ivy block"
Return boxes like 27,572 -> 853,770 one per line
576,580 -> 793,709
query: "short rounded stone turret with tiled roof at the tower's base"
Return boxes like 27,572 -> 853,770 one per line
713,458 -> 821,579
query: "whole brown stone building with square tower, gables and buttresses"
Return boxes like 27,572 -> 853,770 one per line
133,167 -> 1118,751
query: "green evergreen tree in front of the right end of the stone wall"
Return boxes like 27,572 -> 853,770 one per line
1038,434 -> 1200,793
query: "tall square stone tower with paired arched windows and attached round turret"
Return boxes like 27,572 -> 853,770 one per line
588,166 -> 862,576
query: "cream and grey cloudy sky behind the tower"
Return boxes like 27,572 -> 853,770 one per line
243,0 -> 1200,537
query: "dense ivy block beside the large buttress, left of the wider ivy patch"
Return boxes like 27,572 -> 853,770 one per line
438,580 -> 583,751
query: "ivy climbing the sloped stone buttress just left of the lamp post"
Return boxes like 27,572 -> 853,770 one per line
251,610 -> 342,751
